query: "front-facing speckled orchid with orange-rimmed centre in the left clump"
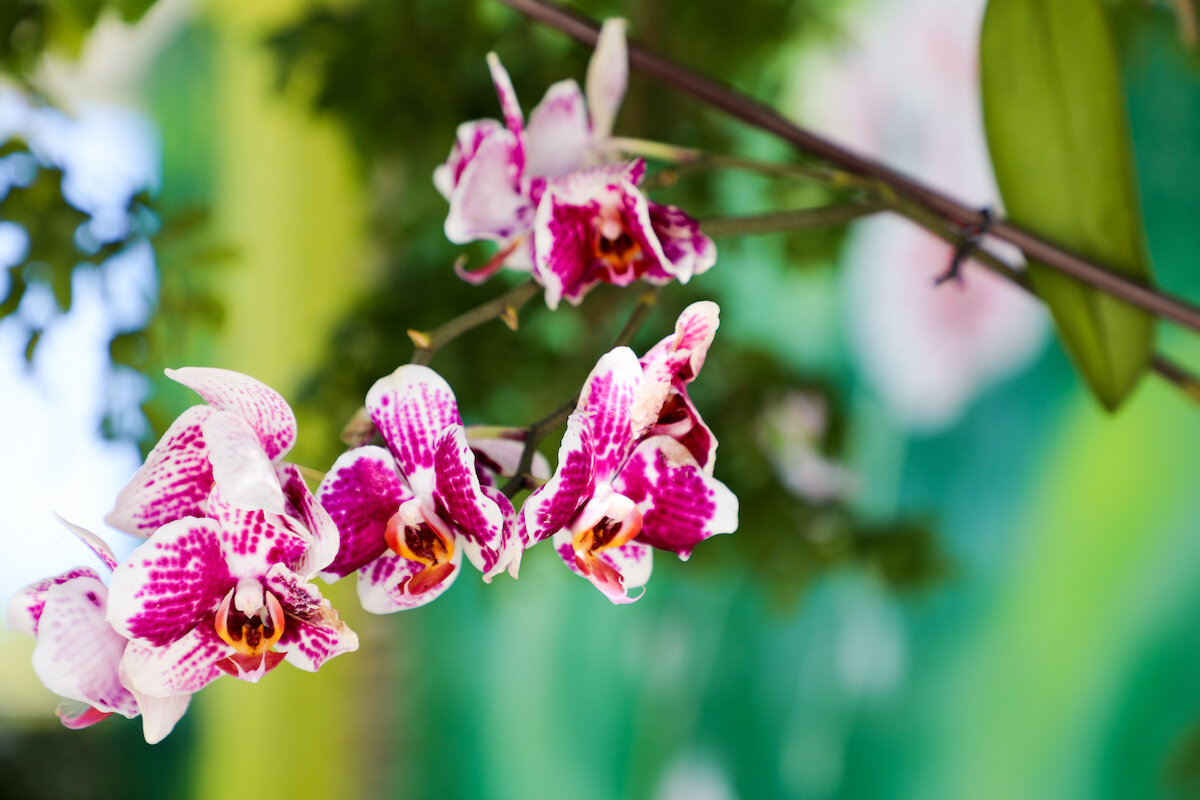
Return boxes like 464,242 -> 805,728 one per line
108,467 -> 359,697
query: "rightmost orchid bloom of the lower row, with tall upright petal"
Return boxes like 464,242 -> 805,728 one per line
523,303 -> 738,603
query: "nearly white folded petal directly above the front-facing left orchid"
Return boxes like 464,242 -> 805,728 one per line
203,411 -> 287,513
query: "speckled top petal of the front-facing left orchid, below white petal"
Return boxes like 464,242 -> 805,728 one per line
209,488 -> 312,578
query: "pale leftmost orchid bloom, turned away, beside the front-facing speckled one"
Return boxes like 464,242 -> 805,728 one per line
8,518 -> 191,744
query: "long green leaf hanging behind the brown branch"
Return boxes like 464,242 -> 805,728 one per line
980,0 -> 1154,410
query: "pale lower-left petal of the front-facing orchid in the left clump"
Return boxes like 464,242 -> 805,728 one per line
121,614 -> 235,697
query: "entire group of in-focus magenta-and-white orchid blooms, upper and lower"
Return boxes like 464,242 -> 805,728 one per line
8,22 -> 738,742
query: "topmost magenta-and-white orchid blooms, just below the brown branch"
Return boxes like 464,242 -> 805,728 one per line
433,19 -> 716,308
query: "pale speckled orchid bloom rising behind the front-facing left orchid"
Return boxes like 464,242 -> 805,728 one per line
104,367 -> 304,539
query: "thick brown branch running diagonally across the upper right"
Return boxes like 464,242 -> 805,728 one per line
500,0 -> 1200,332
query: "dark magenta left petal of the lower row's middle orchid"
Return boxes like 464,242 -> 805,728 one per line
317,446 -> 413,579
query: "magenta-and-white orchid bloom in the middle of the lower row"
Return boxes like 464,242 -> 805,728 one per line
318,365 -> 516,614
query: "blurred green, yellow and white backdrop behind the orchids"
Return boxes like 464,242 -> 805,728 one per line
0,0 -> 1200,800
